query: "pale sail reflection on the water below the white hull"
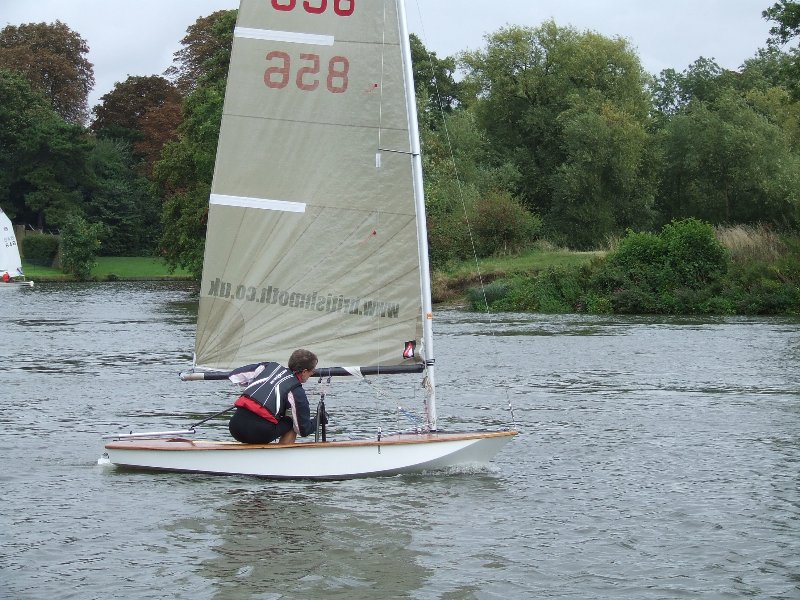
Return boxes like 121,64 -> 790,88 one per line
200,484 -> 430,598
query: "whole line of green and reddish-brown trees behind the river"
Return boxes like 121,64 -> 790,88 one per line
0,0 -> 800,275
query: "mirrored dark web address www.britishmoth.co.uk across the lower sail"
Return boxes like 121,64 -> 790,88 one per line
207,277 -> 400,319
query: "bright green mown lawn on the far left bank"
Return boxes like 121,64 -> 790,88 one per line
22,256 -> 189,281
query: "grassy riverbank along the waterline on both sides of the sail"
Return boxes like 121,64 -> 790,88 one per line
23,243 -> 800,316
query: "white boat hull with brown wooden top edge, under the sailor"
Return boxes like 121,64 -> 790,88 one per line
105,431 -> 516,479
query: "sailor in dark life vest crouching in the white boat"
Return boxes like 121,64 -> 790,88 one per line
228,350 -> 317,444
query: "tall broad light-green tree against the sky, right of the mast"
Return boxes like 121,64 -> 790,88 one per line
462,21 -> 652,247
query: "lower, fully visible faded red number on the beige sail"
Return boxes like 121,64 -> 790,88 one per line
264,50 -> 350,94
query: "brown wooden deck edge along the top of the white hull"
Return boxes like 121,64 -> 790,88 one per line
105,431 -> 517,452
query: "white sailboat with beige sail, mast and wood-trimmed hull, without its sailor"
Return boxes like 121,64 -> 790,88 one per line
104,0 -> 516,479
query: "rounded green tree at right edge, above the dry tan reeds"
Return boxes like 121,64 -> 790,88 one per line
658,90 -> 800,226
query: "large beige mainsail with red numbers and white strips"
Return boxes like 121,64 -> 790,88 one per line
195,0 -> 427,369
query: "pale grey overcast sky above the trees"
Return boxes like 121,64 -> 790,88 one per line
0,0 -> 774,106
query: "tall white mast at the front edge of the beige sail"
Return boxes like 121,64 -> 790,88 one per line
397,0 -> 436,431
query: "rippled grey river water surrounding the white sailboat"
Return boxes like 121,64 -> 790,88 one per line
0,283 -> 800,600
